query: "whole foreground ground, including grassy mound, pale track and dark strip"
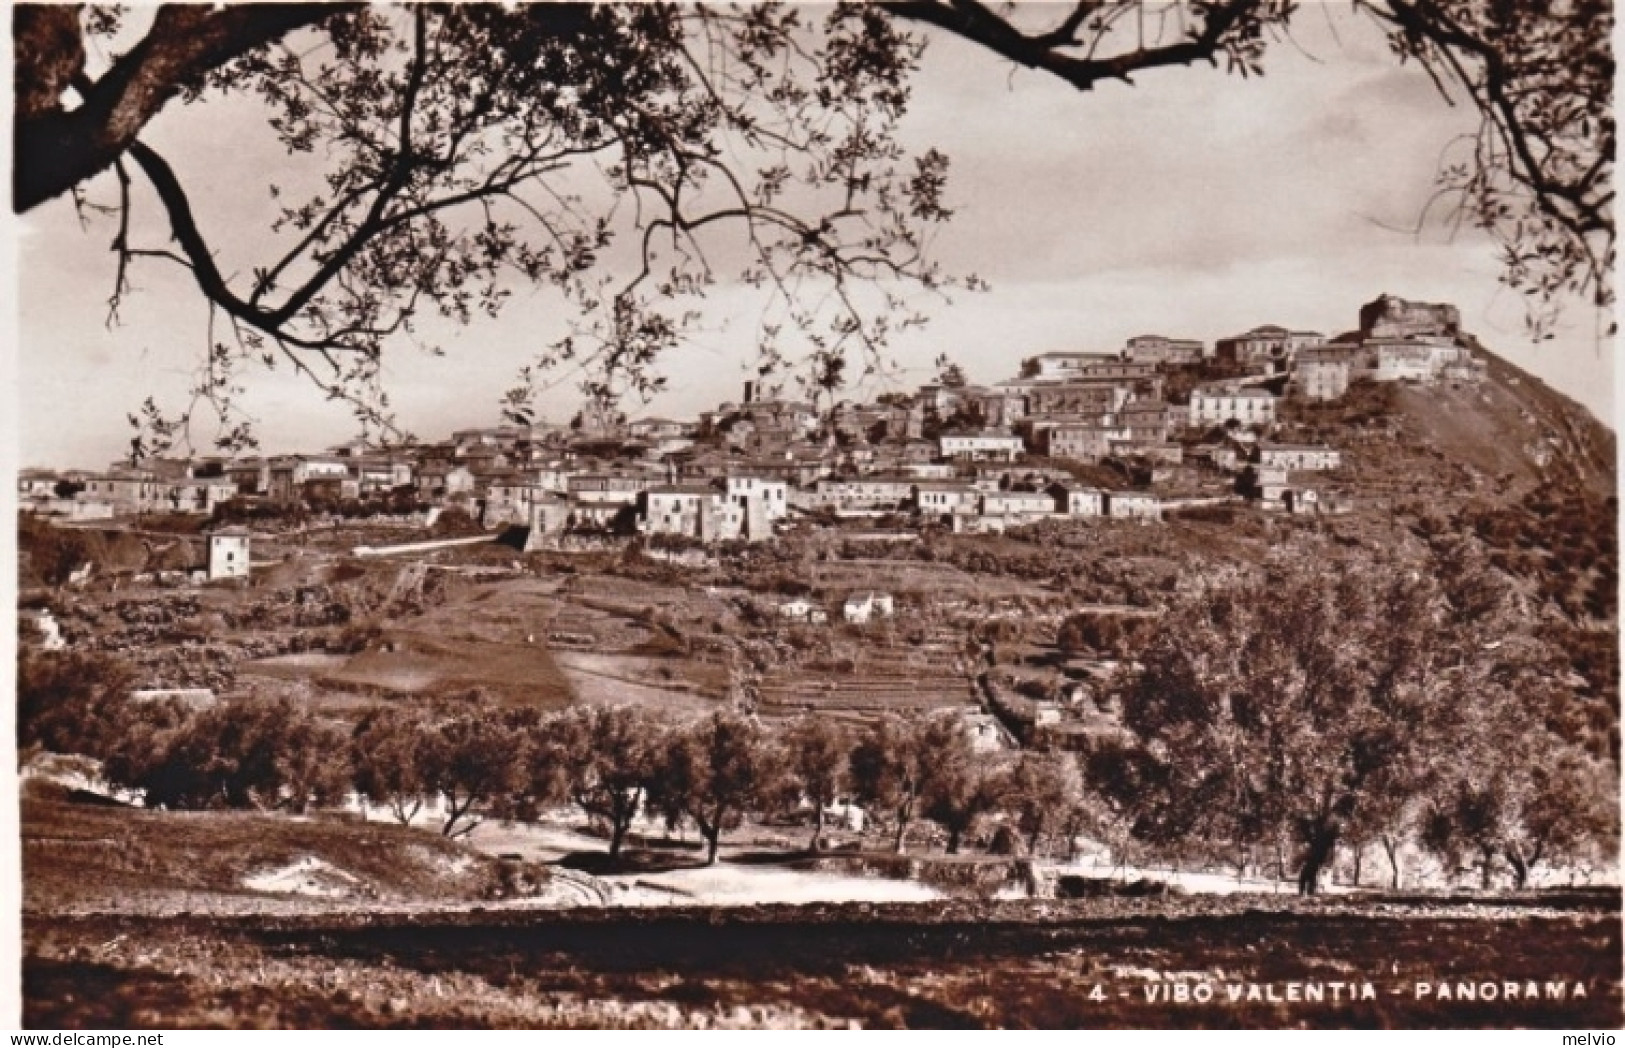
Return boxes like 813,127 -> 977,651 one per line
23,778 -> 1622,1029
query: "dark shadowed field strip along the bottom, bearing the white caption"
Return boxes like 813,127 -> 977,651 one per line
24,892 -> 1622,1029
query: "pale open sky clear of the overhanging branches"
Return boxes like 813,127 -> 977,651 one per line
18,5 -> 1614,468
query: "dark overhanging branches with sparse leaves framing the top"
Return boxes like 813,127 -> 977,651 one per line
13,0 -> 1614,450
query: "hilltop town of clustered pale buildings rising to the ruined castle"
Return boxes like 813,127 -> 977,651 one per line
20,294 -> 1485,542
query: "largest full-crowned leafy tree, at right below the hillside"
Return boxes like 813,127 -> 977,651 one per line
1123,557 -> 1502,894
